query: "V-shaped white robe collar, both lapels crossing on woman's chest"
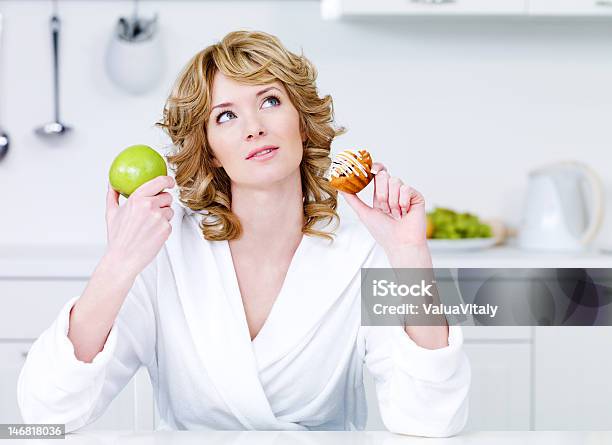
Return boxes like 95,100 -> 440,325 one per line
166,200 -> 374,430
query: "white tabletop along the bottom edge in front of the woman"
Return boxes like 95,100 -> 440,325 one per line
5,431 -> 612,445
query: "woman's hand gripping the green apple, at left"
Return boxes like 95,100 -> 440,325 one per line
106,176 -> 175,276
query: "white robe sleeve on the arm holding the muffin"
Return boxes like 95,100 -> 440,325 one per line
359,241 -> 471,437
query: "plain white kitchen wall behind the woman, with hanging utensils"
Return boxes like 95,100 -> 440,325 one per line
0,0 -> 612,245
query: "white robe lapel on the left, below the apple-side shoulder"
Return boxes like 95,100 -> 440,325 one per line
166,204 -> 305,430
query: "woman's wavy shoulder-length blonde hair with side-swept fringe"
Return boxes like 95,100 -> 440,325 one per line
155,31 -> 346,241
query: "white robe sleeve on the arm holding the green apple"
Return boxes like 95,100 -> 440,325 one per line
17,261 -> 156,432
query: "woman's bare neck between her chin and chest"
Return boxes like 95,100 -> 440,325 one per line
232,170 -> 304,247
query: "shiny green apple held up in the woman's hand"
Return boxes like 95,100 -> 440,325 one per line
108,145 -> 168,198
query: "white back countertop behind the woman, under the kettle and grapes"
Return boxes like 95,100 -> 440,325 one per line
0,239 -> 612,279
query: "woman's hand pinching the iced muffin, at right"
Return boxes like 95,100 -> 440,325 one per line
339,162 -> 427,251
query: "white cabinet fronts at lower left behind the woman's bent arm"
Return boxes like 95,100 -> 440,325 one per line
0,278 -> 154,430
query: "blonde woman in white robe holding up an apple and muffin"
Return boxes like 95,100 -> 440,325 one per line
18,31 -> 470,436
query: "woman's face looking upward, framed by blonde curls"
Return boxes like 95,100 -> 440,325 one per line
206,72 -> 304,187
